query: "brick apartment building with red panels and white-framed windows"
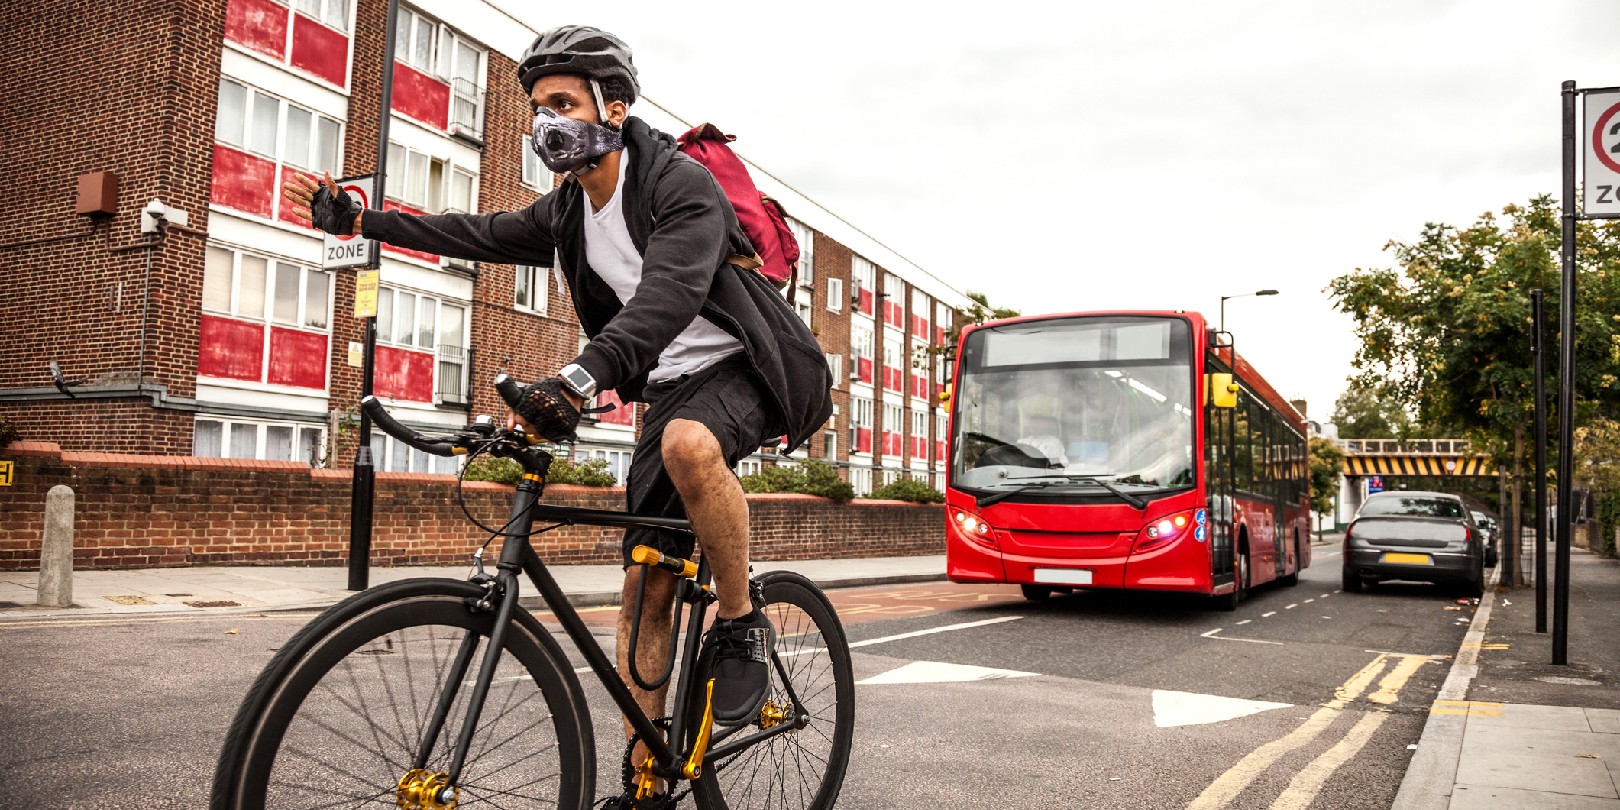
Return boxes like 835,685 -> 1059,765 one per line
0,0 -> 966,492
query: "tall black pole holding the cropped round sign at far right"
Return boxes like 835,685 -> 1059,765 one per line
1552,81 -> 1576,664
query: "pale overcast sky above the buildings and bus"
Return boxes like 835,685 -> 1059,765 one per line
525,0 -> 1620,418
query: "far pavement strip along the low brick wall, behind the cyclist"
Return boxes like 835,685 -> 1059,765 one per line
0,554 -> 944,627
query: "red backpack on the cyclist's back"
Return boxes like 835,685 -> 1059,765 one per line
677,123 -> 799,300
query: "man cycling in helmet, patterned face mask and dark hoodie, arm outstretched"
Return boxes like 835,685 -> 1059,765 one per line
284,26 -> 833,803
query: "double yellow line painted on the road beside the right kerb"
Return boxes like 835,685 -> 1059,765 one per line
1187,653 -> 1432,810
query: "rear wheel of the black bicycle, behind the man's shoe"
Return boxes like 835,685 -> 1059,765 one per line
692,572 -> 855,810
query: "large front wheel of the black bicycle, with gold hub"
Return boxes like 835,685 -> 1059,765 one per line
211,580 -> 596,810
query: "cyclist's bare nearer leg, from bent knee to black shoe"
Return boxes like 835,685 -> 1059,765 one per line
663,420 -> 753,619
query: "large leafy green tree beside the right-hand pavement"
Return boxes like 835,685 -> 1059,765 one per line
1328,196 -> 1620,570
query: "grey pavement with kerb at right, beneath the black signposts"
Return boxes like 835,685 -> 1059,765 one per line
1393,543 -> 1620,810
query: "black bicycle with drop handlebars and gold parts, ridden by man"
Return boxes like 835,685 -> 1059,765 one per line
211,374 -> 855,810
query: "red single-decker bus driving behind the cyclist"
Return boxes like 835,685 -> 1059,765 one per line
944,311 -> 1311,609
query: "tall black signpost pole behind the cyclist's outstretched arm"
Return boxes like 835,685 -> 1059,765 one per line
348,0 -> 399,591
